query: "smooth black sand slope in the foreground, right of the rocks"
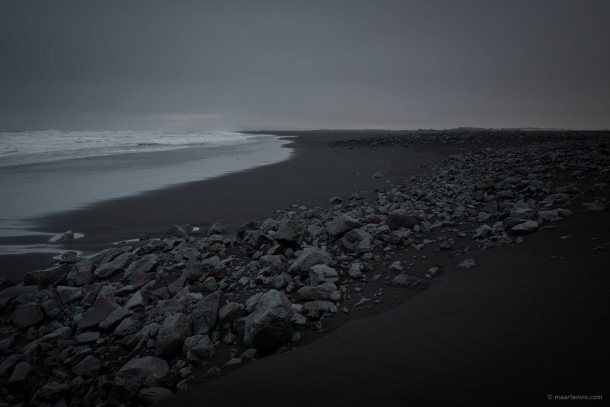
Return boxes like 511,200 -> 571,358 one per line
159,213 -> 610,406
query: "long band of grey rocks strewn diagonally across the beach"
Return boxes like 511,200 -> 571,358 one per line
0,132 -> 610,406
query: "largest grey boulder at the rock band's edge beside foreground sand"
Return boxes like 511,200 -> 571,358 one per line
244,290 -> 292,351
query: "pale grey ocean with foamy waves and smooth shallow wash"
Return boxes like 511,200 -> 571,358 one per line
0,130 -> 292,255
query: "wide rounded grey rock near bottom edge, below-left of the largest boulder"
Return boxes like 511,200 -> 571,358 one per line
113,356 -> 169,399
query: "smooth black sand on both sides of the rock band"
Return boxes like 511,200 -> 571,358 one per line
0,132 -> 610,406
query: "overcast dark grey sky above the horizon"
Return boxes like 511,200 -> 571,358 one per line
0,0 -> 610,130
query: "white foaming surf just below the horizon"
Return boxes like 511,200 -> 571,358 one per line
0,130 -> 261,167
